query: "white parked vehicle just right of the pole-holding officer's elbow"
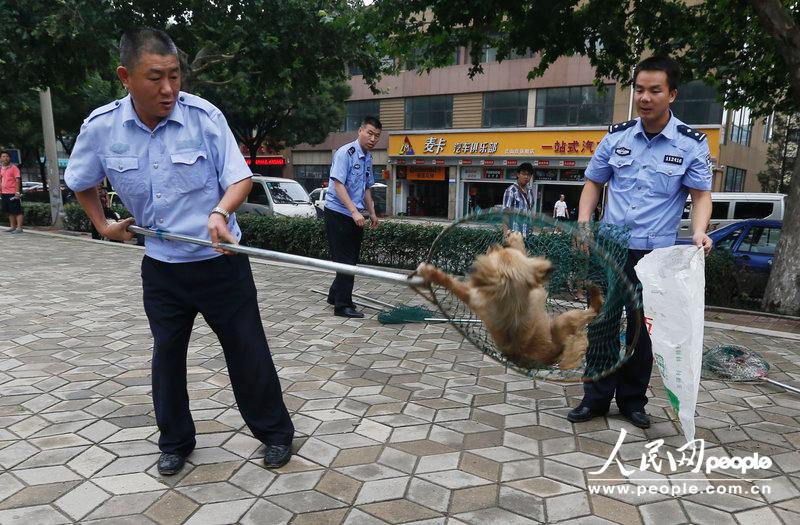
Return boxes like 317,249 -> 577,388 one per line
237,176 -> 316,217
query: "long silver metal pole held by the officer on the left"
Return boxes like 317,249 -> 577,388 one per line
128,222 -> 425,286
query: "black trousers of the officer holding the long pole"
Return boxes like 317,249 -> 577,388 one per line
142,255 -> 294,456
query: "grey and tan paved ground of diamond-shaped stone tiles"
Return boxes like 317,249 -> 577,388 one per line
0,233 -> 800,525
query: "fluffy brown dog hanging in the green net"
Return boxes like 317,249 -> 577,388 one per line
417,232 -> 603,369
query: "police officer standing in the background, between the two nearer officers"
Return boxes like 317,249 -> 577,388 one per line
325,117 -> 382,318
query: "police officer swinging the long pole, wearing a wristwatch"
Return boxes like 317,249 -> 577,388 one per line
64,28 -> 294,475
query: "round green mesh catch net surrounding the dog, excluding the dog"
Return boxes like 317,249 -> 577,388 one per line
416,211 -> 641,381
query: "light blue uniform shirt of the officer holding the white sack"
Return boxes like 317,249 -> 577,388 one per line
586,115 -> 712,250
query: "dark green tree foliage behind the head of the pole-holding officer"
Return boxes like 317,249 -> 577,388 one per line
0,0 -> 382,166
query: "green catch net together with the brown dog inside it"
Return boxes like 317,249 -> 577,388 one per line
417,211 -> 641,381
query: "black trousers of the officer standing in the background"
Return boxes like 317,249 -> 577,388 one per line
325,208 -> 364,309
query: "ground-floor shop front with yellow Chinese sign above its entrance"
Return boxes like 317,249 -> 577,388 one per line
387,126 -> 720,220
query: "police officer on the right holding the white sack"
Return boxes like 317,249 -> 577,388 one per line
567,57 -> 712,428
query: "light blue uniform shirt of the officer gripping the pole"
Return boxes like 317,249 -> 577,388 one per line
64,92 -> 252,263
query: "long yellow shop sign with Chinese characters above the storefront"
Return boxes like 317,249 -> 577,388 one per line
388,128 -> 720,159
